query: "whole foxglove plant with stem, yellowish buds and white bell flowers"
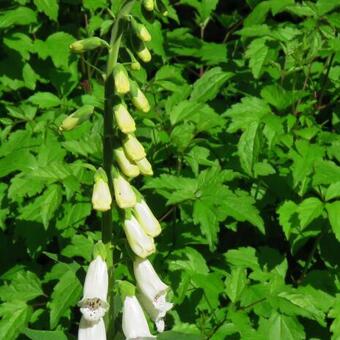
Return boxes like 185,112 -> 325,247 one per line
64,0 -> 172,340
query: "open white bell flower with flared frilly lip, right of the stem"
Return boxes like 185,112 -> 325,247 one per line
133,258 -> 173,332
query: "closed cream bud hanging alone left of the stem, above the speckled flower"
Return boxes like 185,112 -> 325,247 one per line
92,168 -> 112,211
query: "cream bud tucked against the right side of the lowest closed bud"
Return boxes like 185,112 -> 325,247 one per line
133,200 -> 162,237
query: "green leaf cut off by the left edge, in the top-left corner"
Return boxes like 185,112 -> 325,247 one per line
0,6 -> 37,29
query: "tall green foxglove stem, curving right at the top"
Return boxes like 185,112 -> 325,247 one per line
102,0 -> 135,339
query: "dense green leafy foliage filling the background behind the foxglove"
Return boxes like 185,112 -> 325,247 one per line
0,0 -> 340,340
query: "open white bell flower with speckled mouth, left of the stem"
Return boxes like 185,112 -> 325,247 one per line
78,256 -> 109,323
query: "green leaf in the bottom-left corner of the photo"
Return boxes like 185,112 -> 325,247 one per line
0,300 -> 32,339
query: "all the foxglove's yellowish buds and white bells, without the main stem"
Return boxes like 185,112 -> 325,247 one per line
64,0 -> 172,340
